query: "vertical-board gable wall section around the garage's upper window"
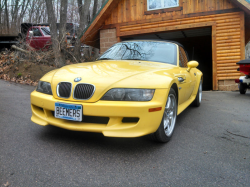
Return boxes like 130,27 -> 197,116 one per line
105,0 -> 237,25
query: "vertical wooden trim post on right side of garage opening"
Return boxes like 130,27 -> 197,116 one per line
212,24 -> 218,90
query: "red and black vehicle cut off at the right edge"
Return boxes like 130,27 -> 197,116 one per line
235,58 -> 250,94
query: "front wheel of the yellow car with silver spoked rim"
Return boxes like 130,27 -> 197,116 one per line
151,88 -> 177,143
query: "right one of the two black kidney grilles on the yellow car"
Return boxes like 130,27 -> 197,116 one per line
74,83 -> 95,100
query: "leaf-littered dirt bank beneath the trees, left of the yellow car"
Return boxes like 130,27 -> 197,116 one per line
0,45 -> 99,86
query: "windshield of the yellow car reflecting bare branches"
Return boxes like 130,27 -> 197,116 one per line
98,41 -> 177,65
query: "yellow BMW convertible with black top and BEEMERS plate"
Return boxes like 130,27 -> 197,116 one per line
31,40 -> 202,142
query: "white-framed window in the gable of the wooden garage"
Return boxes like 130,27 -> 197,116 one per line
147,0 -> 179,10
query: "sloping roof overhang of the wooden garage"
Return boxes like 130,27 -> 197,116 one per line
80,0 -> 250,48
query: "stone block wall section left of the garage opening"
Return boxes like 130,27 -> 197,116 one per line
100,29 -> 117,54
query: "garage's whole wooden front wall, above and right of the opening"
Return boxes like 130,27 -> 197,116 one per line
99,0 -> 245,90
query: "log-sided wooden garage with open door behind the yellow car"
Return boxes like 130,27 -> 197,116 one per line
81,0 -> 250,90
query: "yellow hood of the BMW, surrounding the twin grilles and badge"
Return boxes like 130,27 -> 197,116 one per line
48,60 -> 177,102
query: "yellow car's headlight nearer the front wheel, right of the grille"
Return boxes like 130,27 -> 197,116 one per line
101,88 -> 155,101
